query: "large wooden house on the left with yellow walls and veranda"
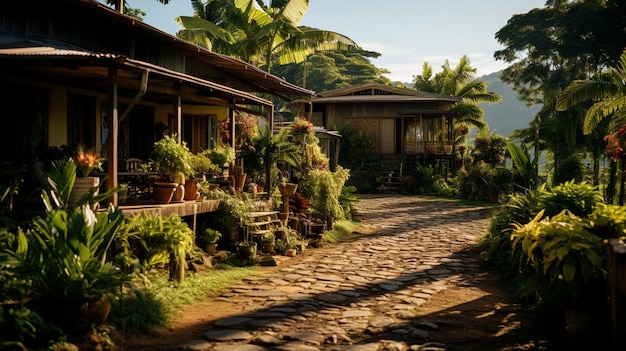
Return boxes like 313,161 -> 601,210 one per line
0,0 -> 314,206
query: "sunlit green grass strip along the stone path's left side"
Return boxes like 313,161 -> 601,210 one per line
108,264 -> 260,332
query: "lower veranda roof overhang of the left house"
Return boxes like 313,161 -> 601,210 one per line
0,35 -> 273,107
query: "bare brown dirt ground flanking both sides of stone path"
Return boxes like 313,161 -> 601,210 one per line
114,248 -> 575,351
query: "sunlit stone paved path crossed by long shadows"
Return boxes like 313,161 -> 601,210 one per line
180,195 -> 491,351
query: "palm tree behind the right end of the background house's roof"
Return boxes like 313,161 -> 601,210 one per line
413,56 -> 502,140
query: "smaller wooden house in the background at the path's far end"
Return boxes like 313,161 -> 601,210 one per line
301,83 -> 461,173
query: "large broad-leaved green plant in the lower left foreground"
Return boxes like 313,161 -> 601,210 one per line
3,160 -> 129,327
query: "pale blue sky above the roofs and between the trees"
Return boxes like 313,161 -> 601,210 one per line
127,0 -> 546,83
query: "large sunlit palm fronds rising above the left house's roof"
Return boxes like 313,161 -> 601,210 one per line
176,0 -> 358,72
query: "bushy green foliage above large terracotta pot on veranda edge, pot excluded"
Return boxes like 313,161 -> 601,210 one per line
151,135 -> 193,182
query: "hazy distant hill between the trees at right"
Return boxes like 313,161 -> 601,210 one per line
479,72 -> 541,136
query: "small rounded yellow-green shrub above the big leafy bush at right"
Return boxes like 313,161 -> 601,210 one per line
539,180 -> 602,217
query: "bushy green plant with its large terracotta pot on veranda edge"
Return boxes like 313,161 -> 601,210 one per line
152,135 -> 192,203
